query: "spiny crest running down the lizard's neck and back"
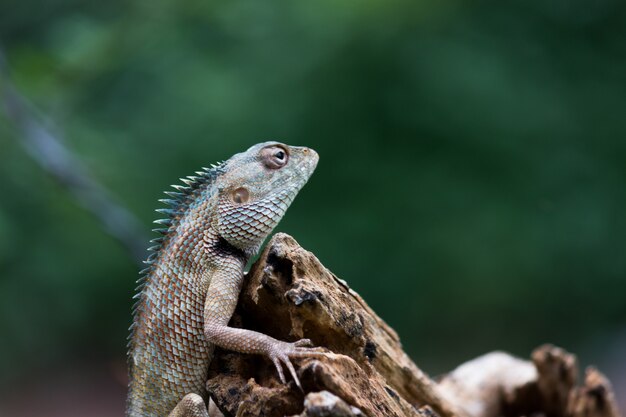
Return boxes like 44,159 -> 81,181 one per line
127,162 -> 225,354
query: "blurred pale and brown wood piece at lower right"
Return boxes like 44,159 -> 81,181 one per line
440,345 -> 620,417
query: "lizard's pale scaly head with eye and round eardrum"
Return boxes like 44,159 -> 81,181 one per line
213,142 -> 319,255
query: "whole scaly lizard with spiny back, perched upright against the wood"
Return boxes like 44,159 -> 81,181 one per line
126,142 -> 320,417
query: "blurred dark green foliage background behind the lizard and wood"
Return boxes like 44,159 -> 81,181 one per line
0,0 -> 626,415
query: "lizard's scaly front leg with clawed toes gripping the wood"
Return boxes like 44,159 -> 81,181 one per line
204,258 -> 324,388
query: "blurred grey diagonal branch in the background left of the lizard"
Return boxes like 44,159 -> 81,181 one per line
0,49 -> 147,262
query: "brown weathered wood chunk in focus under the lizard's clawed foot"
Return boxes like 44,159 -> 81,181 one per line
208,234 -> 450,417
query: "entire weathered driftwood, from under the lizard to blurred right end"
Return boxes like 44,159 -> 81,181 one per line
207,234 -> 619,417
